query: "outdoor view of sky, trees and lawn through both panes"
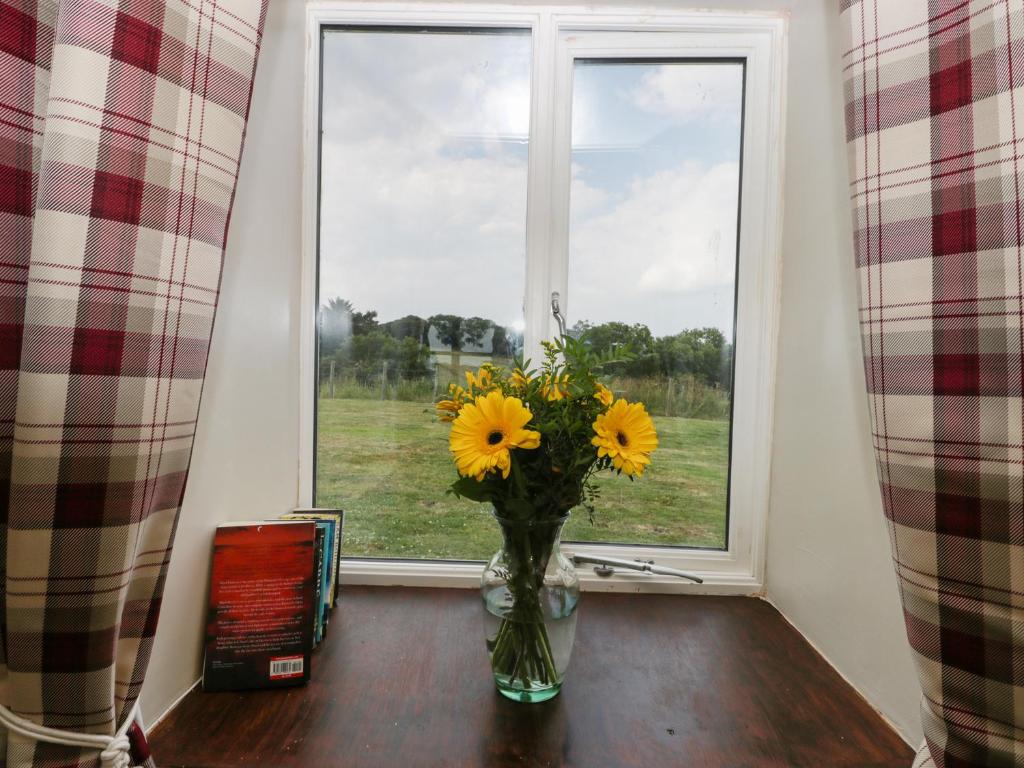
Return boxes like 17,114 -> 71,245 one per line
315,28 -> 743,559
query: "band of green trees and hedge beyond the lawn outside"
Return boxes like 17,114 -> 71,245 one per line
319,298 -> 732,419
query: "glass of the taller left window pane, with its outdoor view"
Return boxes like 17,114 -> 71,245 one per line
315,29 -> 530,559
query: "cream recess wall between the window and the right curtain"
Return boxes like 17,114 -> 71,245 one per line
766,0 -> 921,746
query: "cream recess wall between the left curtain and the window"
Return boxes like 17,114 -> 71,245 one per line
142,0 -> 305,722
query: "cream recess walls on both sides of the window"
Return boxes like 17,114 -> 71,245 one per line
143,0 -> 921,740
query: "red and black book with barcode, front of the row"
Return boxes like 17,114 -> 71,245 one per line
203,520 -> 318,690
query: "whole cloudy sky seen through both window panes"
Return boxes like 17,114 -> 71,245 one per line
319,31 -> 742,336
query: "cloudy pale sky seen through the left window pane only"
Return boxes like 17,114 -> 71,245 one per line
321,28 -> 529,323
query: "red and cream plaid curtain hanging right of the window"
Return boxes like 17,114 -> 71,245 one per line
840,0 -> 1024,768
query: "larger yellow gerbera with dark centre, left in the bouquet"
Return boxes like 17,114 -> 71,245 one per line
449,391 -> 541,480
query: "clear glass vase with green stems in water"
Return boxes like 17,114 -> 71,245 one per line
480,513 -> 580,702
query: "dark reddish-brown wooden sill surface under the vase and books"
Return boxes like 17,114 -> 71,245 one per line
151,587 -> 911,768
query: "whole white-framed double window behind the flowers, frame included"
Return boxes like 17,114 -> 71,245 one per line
299,4 -> 782,589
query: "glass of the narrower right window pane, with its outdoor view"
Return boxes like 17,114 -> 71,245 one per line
566,59 -> 743,548
